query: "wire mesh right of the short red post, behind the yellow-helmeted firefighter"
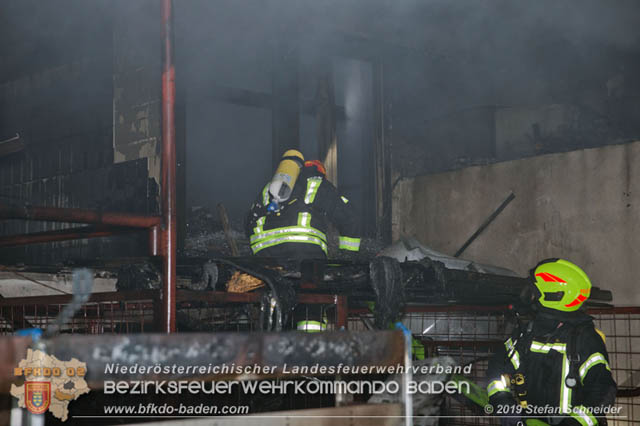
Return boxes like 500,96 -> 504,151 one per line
349,306 -> 640,425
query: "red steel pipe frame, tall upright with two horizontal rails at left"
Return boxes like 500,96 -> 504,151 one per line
0,0 -> 177,333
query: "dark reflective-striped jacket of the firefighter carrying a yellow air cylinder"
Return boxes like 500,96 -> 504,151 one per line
245,167 -> 360,259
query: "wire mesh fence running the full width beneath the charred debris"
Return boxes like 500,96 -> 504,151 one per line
0,290 -> 640,425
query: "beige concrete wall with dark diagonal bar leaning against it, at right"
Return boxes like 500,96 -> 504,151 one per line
393,142 -> 640,305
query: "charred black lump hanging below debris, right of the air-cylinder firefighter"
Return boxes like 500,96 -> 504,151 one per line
369,256 -> 405,330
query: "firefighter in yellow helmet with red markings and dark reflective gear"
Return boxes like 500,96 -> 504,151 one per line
487,259 -> 617,426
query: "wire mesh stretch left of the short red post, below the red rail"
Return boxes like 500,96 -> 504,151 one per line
0,290 -> 346,334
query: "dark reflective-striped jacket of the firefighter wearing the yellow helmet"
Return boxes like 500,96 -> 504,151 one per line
487,309 -> 616,426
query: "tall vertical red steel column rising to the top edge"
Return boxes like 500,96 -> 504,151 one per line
161,0 -> 177,333
